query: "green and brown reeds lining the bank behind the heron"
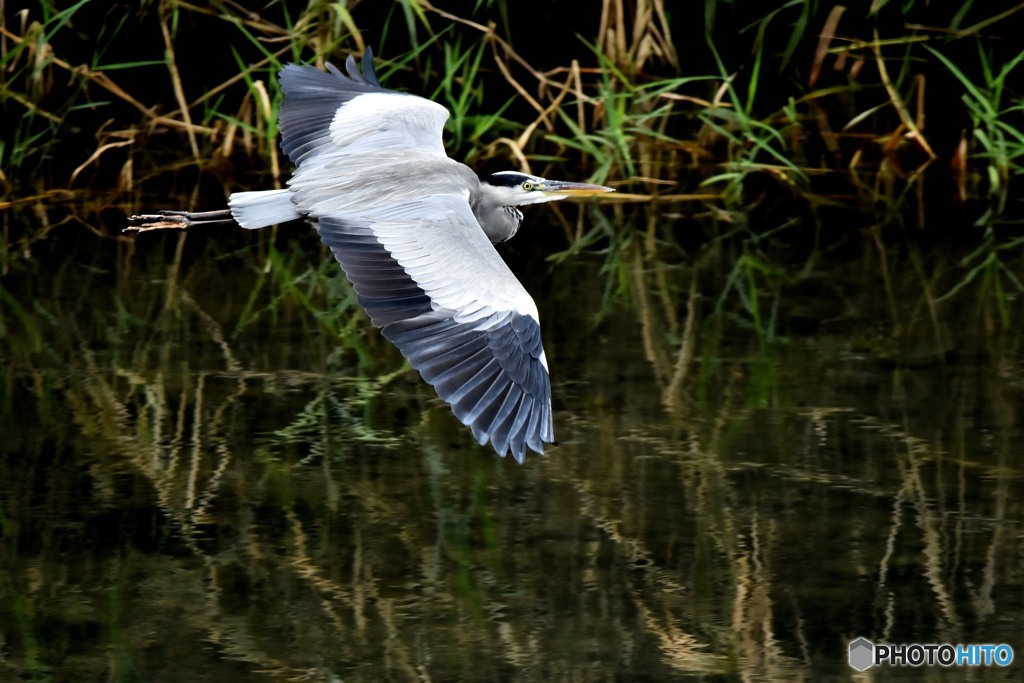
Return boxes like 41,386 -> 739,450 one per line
0,0 -> 1024,218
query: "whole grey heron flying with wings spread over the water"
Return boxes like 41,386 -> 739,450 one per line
126,49 -> 613,463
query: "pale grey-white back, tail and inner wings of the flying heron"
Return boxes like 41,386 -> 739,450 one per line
228,114 -> 547,339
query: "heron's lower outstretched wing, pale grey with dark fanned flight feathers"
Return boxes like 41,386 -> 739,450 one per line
317,208 -> 553,462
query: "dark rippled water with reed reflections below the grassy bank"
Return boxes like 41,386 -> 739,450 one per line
0,210 -> 1024,681
